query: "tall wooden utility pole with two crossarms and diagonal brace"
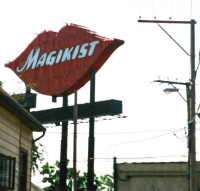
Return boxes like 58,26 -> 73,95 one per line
138,20 -> 197,191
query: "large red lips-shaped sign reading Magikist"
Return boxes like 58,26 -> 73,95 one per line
5,24 -> 124,96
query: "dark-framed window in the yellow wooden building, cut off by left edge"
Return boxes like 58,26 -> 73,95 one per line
0,154 -> 15,190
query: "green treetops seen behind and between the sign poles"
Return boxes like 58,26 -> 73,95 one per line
40,161 -> 114,191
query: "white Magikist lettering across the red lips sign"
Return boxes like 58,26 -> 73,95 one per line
16,40 -> 100,73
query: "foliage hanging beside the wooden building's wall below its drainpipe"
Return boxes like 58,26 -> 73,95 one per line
32,143 -> 44,174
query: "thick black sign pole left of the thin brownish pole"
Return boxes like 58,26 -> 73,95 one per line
59,94 -> 68,191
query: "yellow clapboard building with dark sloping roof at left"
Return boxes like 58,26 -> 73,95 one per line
0,87 -> 45,191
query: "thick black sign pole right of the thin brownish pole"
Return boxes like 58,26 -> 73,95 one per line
87,70 -> 96,191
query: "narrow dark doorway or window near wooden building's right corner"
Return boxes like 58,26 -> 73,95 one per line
20,147 -> 28,191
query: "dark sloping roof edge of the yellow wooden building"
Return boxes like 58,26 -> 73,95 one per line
0,87 -> 46,132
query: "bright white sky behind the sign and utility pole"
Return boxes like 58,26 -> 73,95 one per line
0,0 -> 200,188
